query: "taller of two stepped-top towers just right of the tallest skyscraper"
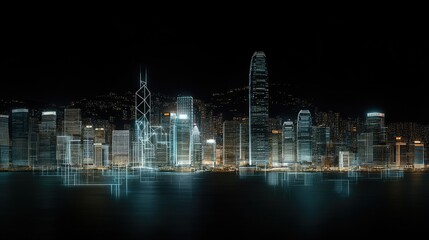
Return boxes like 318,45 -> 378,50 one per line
296,110 -> 312,164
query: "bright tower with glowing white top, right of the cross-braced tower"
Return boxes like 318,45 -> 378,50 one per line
173,114 -> 191,166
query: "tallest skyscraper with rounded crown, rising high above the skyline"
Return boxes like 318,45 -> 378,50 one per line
249,51 -> 269,165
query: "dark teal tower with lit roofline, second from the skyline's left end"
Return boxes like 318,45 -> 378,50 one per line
11,108 -> 30,167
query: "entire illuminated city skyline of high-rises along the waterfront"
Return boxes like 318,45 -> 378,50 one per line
0,51 -> 429,171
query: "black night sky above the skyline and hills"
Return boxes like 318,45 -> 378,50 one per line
0,13 -> 429,122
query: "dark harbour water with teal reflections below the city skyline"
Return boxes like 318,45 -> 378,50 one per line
0,172 -> 429,239
